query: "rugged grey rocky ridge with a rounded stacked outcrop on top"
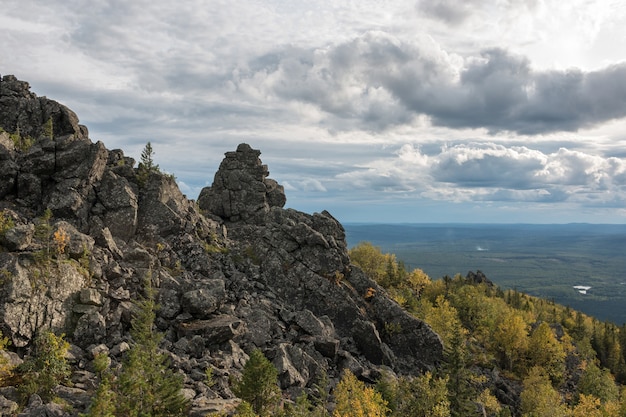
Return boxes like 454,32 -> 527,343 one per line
0,76 -> 443,416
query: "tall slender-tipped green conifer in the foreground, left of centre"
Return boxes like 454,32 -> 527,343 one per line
116,276 -> 188,417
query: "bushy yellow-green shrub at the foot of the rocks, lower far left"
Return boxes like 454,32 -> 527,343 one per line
17,331 -> 71,401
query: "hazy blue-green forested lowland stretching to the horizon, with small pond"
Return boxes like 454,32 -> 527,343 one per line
344,223 -> 626,324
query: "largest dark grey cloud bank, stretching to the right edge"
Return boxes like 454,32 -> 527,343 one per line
240,32 -> 626,134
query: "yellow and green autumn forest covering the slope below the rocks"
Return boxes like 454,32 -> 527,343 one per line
350,242 -> 626,416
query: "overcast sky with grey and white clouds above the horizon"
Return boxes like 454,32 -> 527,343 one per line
0,0 -> 626,223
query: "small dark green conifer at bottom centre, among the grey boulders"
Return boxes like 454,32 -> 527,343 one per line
233,349 -> 281,416
